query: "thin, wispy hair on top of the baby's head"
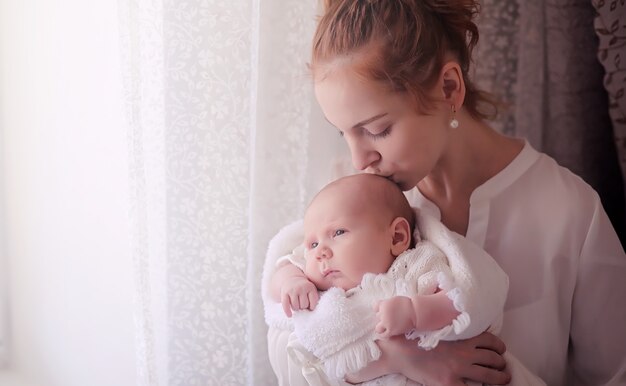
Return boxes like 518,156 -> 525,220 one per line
311,173 -> 415,246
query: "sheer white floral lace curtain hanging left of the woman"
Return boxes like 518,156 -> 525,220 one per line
119,0 -> 339,385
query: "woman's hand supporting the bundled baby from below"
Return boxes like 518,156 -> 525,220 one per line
377,332 -> 511,386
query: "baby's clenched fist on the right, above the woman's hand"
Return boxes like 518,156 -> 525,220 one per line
374,296 -> 415,339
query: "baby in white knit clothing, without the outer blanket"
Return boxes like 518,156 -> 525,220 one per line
270,174 -> 478,382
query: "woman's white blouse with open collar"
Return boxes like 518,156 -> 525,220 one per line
407,143 -> 626,386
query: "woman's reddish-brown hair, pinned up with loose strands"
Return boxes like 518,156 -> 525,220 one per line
310,0 -> 497,119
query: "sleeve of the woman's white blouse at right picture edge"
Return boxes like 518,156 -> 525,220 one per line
568,196 -> 626,385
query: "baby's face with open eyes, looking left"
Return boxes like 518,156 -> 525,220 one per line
304,186 -> 394,290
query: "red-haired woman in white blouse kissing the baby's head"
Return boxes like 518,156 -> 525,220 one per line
269,0 -> 626,385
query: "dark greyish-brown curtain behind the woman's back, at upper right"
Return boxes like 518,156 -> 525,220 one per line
474,0 -> 626,245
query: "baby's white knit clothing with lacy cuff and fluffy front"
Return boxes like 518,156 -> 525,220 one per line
292,240 -> 498,379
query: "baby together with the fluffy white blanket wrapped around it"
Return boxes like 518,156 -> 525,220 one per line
265,174 -> 543,386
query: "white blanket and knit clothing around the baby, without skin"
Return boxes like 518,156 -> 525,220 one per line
262,212 -> 508,379
